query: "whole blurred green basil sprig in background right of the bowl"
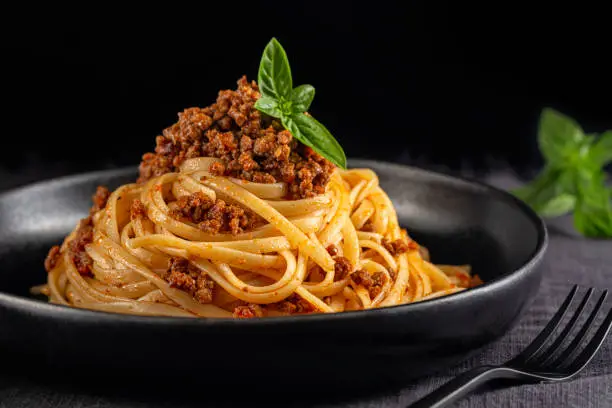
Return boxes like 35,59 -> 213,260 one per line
514,109 -> 612,237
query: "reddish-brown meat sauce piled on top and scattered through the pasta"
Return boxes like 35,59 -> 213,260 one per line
45,76 -> 342,318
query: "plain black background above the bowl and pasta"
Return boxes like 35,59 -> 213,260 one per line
0,1 -> 612,185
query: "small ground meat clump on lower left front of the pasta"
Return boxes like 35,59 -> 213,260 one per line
162,258 -> 215,303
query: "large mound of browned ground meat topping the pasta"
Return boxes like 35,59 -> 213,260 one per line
138,77 -> 334,198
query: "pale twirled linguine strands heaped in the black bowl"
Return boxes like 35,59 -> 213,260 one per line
35,157 -> 474,317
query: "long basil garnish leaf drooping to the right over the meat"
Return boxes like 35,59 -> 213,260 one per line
282,113 -> 346,169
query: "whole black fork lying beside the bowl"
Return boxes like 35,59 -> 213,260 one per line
410,285 -> 612,408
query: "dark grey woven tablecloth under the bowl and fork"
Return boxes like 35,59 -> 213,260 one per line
0,173 -> 612,408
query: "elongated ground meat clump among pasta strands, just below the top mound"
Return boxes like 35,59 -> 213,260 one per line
170,192 -> 264,235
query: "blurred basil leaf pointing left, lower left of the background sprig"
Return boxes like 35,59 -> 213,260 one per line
513,167 -> 576,217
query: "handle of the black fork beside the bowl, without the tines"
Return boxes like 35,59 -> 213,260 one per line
410,366 -> 518,408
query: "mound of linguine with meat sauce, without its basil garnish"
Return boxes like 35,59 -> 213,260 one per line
33,39 -> 480,318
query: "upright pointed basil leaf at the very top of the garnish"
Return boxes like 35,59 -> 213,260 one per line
257,38 -> 293,100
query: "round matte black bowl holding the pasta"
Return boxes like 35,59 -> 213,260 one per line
0,160 -> 547,387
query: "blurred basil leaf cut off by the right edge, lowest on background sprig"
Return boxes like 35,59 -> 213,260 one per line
574,172 -> 612,238
